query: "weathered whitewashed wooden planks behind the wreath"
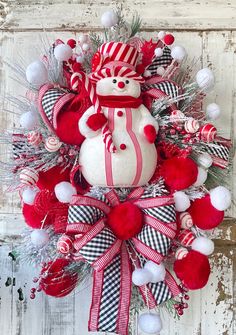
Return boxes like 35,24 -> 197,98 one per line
0,0 -> 236,335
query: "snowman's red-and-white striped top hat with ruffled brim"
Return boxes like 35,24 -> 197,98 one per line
89,42 -> 144,82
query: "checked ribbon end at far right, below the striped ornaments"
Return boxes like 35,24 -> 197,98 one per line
205,136 -> 232,169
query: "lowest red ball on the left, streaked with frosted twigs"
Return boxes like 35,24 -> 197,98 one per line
40,258 -> 78,298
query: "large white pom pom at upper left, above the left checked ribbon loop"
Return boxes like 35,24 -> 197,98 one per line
25,60 -> 48,86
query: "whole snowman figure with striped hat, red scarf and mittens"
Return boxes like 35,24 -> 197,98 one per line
79,42 -> 158,187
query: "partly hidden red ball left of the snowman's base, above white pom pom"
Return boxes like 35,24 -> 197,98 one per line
37,166 -> 70,191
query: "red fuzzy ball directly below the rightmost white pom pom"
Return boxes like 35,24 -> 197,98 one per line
188,194 -> 224,230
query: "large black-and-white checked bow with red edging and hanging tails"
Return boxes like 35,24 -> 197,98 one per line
67,188 -> 180,335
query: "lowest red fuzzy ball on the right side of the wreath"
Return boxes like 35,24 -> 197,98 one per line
174,250 -> 211,290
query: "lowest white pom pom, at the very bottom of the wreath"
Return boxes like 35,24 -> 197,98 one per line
138,313 -> 162,335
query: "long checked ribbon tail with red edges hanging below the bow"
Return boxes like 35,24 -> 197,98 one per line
89,243 -> 131,335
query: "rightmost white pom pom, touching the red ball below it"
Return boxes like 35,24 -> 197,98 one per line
210,186 -> 231,211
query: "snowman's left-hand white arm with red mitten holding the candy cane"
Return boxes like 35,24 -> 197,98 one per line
78,106 -> 107,137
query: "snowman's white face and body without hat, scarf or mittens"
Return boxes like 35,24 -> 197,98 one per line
79,77 -> 158,187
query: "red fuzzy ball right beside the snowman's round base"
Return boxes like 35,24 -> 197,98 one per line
160,157 -> 198,191
